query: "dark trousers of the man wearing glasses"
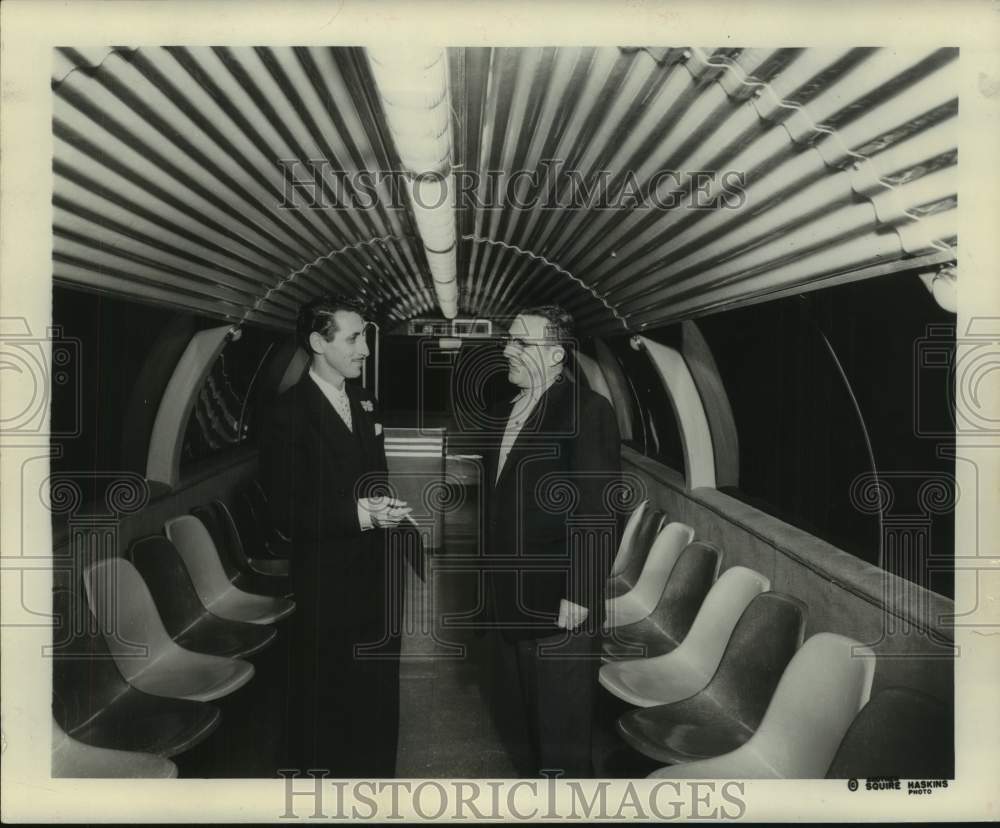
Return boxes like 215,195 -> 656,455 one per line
490,630 -> 600,778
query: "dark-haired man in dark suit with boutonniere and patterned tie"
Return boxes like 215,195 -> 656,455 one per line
261,297 -> 409,778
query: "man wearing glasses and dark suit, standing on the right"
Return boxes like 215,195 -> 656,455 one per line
484,305 -> 620,777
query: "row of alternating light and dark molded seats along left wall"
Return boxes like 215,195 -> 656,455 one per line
52,501 -> 295,777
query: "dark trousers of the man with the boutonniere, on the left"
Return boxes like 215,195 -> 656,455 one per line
286,620 -> 400,779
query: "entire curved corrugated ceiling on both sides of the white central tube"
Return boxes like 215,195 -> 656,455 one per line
53,47 -> 958,333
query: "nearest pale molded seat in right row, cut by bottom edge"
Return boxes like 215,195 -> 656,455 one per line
650,633 -> 875,779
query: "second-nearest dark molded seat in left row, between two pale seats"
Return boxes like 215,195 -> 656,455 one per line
128,535 -> 278,658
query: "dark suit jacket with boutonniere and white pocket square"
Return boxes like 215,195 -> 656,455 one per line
261,373 -> 398,635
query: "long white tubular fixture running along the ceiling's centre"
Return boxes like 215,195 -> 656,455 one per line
367,47 -> 458,319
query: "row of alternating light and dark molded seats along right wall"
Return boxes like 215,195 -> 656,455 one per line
600,503 -> 952,778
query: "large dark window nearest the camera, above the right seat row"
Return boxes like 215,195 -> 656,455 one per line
698,273 -> 954,595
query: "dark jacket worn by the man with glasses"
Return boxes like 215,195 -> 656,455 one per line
483,378 -> 621,639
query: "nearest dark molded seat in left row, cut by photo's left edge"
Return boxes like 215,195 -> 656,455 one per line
52,589 -> 219,756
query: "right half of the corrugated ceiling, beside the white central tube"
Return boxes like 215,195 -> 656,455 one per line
456,49 -> 957,331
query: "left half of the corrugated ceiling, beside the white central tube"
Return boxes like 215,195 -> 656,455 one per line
53,47 -> 433,327
